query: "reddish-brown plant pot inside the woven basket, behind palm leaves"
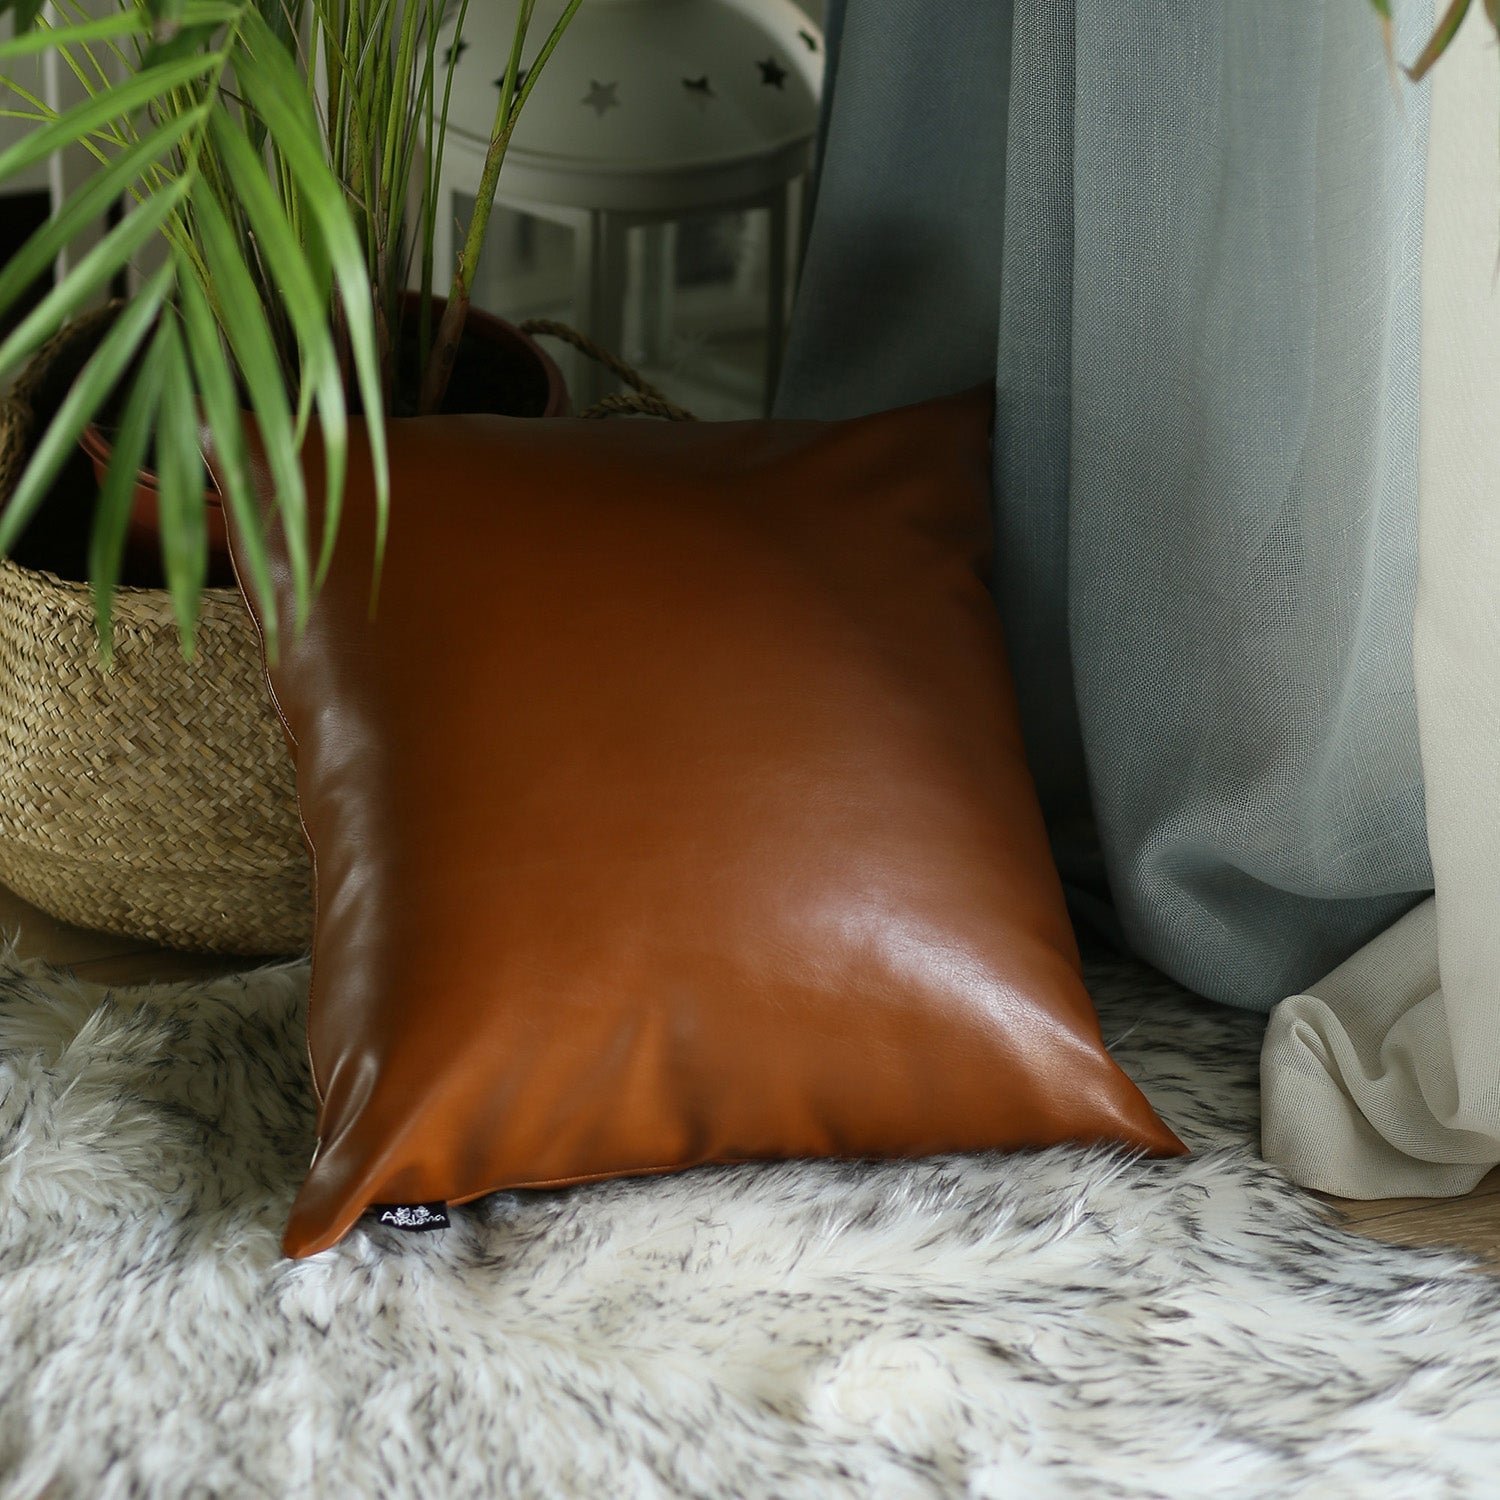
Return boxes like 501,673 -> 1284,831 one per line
80,293 -> 572,587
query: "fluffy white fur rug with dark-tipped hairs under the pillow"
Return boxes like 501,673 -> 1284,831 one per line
0,960 -> 1500,1500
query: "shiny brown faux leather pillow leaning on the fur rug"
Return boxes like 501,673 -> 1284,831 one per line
225,395 -> 1182,1256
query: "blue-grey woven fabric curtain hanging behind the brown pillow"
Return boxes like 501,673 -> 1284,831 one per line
779,0 -> 1433,1010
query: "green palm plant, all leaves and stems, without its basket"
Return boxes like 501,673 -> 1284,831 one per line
0,0 -> 579,654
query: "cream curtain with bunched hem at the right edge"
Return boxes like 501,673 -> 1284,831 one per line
1262,17 -> 1500,1199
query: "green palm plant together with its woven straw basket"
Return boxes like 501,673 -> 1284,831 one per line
0,0 -> 579,953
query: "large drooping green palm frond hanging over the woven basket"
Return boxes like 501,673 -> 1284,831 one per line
0,0 -> 387,650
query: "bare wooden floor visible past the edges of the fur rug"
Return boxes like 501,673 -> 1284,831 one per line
0,887 -> 1500,1271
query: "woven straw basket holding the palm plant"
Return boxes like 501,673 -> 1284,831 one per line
0,315 -> 312,953
